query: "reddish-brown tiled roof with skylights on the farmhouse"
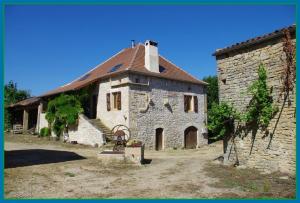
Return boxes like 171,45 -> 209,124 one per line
41,44 -> 207,97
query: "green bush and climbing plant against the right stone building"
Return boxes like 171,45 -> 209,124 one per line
208,64 -> 278,139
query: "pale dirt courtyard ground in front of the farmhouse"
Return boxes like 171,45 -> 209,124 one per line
4,134 -> 296,199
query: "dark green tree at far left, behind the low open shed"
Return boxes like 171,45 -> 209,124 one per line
4,81 -> 30,130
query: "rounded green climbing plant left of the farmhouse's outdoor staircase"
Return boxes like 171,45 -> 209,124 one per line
46,94 -> 83,136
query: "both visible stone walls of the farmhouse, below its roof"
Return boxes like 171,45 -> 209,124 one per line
97,74 -> 207,149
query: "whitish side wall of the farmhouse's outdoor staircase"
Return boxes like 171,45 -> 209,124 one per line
68,115 -> 105,146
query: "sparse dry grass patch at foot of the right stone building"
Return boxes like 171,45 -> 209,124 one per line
204,164 -> 296,198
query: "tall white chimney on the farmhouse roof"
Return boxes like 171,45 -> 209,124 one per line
145,40 -> 159,73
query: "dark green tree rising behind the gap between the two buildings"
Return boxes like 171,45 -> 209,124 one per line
203,76 -> 219,110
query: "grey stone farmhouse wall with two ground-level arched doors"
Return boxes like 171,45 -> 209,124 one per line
129,74 -> 207,148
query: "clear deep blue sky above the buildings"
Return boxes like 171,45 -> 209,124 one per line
4,5 -> 296,96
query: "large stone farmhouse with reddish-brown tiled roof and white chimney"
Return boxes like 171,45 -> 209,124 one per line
10,40 -> 208,150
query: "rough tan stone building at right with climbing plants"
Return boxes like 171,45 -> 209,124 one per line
213,25 -> 296,174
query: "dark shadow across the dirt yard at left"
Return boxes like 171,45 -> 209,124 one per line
4,149 -> 86,168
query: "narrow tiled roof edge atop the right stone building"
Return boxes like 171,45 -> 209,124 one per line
213,25 -> 296,56
